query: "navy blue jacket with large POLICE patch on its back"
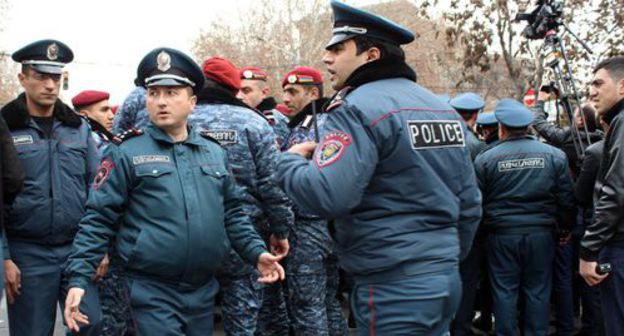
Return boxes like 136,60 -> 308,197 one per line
278,77 -> 481,279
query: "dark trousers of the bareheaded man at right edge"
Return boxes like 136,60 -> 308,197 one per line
599,241 -> 624,336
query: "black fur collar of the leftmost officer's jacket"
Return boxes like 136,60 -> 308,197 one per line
0,93 -> 82,130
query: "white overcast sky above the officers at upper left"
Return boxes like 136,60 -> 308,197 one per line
0,0 -> 374,104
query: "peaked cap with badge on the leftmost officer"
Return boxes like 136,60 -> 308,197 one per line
11,39 -> 74,75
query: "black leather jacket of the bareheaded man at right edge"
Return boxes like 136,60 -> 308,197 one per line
580,99 -> 624,261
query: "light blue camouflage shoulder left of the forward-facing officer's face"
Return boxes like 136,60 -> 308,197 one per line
112,84 -> 149,134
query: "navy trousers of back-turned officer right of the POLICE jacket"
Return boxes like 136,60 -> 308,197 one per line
488,228 -> 555,335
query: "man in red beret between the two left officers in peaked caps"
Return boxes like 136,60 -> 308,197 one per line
72,90 -> 115,157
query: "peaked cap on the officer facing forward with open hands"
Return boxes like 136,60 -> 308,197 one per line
136,48 -> 204,93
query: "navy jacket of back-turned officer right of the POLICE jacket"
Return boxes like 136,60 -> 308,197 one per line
475,136 -> 575,234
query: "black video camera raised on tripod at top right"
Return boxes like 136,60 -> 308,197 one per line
515,0 -> 563,40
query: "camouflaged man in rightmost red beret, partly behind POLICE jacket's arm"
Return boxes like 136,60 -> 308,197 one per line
282,66 -> 349,335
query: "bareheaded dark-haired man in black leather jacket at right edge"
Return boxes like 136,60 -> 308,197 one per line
579,56 -> 624,335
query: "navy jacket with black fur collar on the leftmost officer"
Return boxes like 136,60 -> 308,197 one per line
1,95 -> 98,247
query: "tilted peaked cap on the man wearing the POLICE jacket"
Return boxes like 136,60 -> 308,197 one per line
325,0 -> 414,49
